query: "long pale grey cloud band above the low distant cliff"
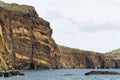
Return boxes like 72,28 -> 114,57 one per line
69,19 -> 120,32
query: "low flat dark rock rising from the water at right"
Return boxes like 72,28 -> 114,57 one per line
85,71 -> 120,75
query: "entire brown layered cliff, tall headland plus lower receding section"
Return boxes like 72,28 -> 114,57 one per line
0,2 -> 118,70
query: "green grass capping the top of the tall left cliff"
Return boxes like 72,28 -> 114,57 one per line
0,1 -> 34,13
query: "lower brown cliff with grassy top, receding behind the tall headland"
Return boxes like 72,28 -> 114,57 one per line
59,46 -> 116,68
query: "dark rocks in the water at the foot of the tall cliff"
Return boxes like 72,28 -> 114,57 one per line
0,71 -> 25,77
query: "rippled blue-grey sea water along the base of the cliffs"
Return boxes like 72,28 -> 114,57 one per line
0,69 -> 120,80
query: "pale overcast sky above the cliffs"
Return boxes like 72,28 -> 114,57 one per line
2,0 -> 120,53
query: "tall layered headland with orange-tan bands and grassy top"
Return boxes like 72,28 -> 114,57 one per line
0,2 -> 57,69
